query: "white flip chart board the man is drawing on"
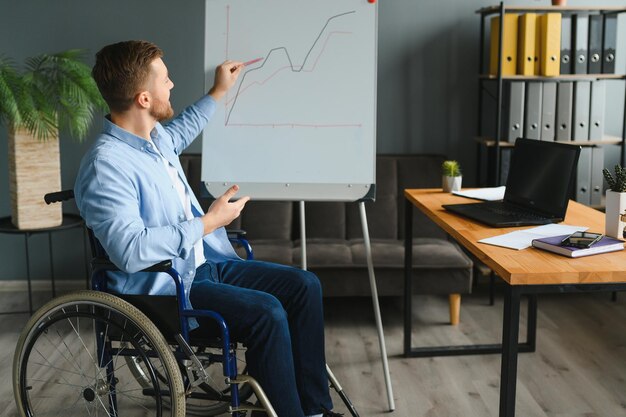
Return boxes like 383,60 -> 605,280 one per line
201,0 -> 378,201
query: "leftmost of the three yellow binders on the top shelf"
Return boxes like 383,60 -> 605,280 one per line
489,13 -> 518,75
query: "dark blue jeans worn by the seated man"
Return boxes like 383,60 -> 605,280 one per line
190,260 -> 332,417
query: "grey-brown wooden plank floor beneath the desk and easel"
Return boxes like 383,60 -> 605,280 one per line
0,287 -> 626,417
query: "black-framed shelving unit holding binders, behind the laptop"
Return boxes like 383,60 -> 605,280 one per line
474,2 -> 626,206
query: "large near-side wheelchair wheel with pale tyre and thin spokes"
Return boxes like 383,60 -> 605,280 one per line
13,291 -> 185,417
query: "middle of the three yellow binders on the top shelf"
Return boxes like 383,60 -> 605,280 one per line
517,13 -> 541,75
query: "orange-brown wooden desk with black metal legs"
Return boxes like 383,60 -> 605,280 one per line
404,189 -> 626,417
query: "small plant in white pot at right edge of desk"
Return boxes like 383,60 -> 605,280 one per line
602,165 -> 626,238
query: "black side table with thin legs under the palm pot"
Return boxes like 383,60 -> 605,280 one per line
0,213 -> 89,315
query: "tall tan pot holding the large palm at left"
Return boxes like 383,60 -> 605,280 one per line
9,130 -> 63,230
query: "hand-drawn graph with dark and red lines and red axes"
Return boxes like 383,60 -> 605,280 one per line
224,6 -> 362,128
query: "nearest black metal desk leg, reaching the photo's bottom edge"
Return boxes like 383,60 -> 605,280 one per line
500,284 -> 520,417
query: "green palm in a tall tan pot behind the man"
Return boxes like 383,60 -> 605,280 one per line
0,50 -> 107,230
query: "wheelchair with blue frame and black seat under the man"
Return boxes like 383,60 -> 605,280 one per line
12,190 -> 359,417
